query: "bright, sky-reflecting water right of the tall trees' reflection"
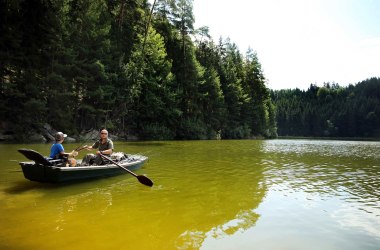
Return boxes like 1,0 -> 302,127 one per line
201,140 -> 380,249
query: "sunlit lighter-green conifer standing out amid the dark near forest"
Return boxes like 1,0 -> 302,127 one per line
127,28 -> 180,139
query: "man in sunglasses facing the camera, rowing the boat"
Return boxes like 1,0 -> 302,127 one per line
81,129 -> 113,166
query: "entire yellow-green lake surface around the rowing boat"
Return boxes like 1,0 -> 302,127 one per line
0,140 -> 380,250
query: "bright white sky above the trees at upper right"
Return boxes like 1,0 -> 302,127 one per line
193,0 -> 380,90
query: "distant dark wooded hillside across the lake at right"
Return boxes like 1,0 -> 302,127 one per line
271,78 -> 380,138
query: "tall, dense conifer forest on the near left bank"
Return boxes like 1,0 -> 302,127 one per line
0,0 -> 278,140
